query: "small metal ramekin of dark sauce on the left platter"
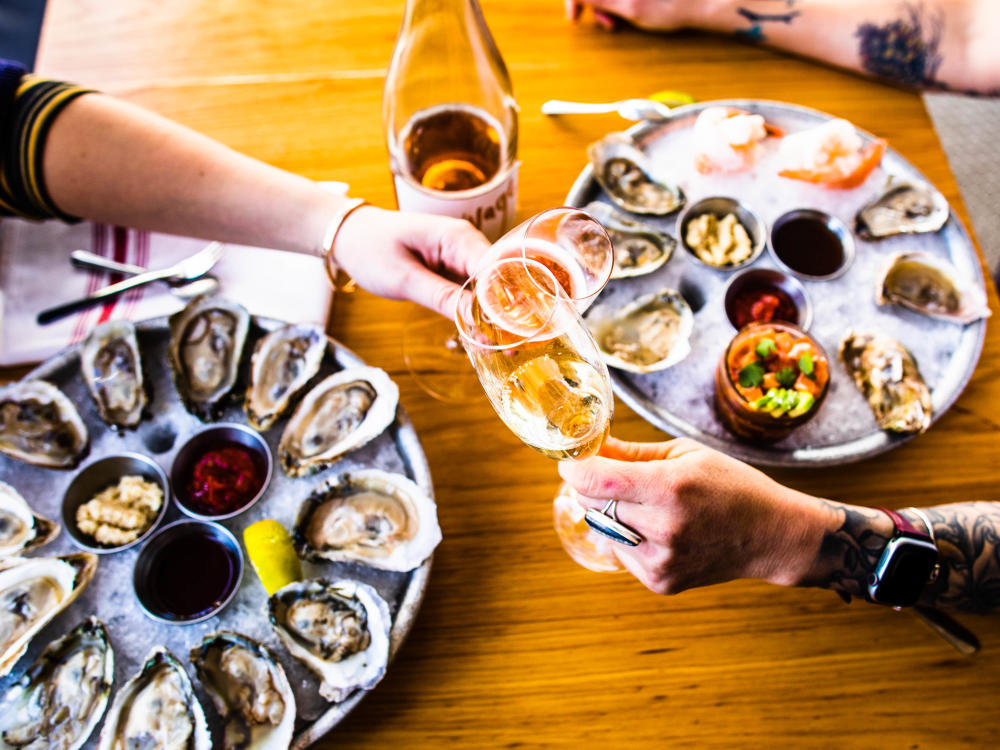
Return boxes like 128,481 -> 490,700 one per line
132,519 -> 244,625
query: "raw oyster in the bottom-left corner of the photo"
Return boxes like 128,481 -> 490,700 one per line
0,617 -> 114,750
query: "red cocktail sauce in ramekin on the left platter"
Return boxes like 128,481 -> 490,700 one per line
187,443 -> 264,516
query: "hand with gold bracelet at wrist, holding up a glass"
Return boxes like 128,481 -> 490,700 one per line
333,206 -> 490,318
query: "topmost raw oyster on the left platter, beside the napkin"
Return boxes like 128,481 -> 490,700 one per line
169,297 -> 250,419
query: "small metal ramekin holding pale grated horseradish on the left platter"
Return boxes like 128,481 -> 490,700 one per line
62,453 -> 170,555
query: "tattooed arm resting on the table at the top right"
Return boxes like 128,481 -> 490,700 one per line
566,0 -> 1000,94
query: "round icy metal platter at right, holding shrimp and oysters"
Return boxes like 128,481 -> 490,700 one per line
566,100 -> 986,466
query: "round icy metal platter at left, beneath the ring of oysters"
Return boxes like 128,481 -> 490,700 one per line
0,317 -> 440,748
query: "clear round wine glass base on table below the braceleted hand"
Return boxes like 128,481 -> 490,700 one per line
403,316 -> 485,404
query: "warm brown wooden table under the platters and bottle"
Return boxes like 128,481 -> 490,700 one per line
38,0 -> 1000,748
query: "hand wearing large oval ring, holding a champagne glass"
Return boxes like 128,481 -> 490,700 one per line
559,438 -> 829,594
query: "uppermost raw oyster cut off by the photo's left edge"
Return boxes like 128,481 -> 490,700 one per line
0,380 -> 90,469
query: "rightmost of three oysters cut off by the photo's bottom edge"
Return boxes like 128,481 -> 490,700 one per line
191,631 -> 295,750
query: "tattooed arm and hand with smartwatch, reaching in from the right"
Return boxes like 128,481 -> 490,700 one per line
559,438 -> 1000,613
